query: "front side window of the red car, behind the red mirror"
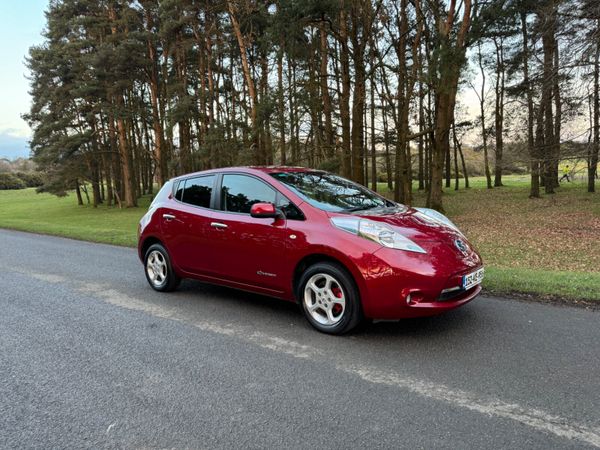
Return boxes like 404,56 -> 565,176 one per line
221,175 -> 276,214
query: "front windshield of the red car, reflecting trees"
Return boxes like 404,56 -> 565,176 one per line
271,172 -> 396,212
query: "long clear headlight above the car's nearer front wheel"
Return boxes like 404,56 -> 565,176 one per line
331,217 -> 427,253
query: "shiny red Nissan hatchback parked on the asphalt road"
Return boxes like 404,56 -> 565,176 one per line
138,167 -> 483,334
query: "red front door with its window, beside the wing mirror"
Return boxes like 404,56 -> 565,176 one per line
211,173 -> 291,292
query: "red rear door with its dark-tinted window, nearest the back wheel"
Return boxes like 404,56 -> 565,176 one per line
161,174 -> 217,275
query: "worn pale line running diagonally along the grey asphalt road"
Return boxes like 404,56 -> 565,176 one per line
6,267 -> 600,447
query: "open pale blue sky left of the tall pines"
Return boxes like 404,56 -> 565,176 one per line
0,0 -> 47,159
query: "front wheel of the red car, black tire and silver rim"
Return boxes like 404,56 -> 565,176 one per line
297,262 -> 363,335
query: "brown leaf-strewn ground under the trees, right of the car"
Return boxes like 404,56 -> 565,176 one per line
444,187 -> 600,272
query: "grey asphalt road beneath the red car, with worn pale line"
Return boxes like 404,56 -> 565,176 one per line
0,230 -> 600,449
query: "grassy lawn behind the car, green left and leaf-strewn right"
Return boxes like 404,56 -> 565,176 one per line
0,176 -> 600,302
